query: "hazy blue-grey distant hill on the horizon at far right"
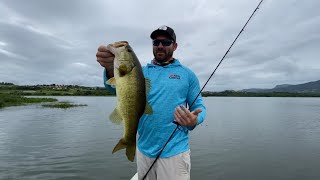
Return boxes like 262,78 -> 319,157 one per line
241,80 -> 320,93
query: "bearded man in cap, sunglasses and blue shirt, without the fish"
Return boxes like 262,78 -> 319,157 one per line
96,26 -> 206,180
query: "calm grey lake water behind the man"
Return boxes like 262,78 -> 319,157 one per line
0,97 -> 320,180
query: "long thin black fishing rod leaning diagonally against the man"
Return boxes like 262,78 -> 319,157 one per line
142,0 -> 263,180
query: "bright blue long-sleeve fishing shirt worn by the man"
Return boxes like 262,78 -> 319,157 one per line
105,59 -> 206,158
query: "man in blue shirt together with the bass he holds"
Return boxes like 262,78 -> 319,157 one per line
96,26 -> 206,180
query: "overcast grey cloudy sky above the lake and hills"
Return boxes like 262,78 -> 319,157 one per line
0,0 -> 320,91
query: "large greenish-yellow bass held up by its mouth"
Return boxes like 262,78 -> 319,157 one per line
106,41 -> 152,161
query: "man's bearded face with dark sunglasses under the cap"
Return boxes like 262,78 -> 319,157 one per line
153,35 -> 177,62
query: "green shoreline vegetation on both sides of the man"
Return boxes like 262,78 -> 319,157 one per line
0,82 -> 320,109
